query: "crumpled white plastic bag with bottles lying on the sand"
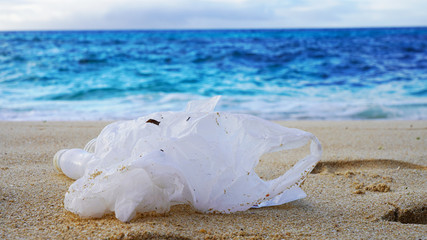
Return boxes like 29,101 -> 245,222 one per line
53,97 -> 322,222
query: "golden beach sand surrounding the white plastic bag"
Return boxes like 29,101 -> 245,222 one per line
0,121 -> 427,239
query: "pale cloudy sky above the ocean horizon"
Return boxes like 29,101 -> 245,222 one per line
0,0 -> 427,31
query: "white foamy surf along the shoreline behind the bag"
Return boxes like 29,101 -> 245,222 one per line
0,94 -> 427,121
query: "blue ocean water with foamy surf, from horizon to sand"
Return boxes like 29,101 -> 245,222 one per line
0,28 -> 427,121
